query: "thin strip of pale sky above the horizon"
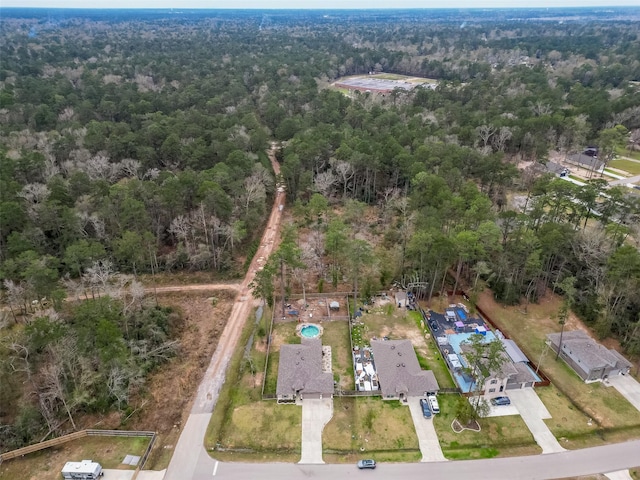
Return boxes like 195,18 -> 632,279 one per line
0,0 -> 640,10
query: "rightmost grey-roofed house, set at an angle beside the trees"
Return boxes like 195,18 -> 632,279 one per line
547,330 -> 631,383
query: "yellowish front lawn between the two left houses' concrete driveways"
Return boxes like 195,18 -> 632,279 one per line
322,397 -> 422,462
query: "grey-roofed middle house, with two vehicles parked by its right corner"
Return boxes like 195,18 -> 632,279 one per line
371,340 -> 440,401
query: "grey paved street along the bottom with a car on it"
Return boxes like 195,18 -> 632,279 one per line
204,440 -> 640,480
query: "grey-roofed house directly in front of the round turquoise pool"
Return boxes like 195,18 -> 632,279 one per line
276,338 -> 333,403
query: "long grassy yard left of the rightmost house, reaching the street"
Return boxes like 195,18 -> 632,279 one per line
479,291 -> 640,448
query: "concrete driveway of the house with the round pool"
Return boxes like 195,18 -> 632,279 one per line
298,398 -> 333,464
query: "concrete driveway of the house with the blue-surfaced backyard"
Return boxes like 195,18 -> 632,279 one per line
506,388 -> 565,453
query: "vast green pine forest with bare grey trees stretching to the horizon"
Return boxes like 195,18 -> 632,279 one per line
0,8 -> 640,449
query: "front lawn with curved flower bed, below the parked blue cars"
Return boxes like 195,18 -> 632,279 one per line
433,395 -> 542,460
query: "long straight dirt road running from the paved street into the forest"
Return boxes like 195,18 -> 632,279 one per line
165,145 -> 285,480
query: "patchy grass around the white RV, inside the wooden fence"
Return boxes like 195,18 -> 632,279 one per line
0,437 -> 149,480
